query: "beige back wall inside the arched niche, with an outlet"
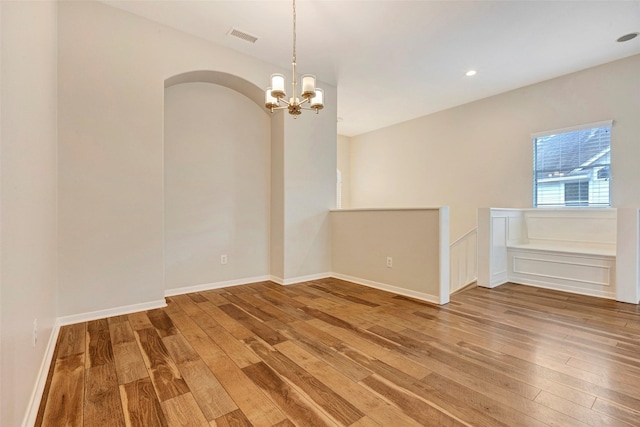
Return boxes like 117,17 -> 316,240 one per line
164,83 -> 271,290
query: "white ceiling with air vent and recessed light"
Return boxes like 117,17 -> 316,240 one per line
104,0 -> 640,136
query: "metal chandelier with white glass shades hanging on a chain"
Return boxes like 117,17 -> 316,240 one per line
265,0 -> 324,119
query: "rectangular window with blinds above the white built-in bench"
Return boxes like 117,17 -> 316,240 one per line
533,121 -> 613,207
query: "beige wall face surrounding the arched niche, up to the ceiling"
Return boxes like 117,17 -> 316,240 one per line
58,2 -> 336,316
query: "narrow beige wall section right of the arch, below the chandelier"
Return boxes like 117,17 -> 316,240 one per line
283,112 -> 337,283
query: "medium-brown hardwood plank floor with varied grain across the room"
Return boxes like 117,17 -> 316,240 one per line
36,279 -> 640,427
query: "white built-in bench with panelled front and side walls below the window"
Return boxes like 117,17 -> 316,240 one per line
478,208 -> 617,299
